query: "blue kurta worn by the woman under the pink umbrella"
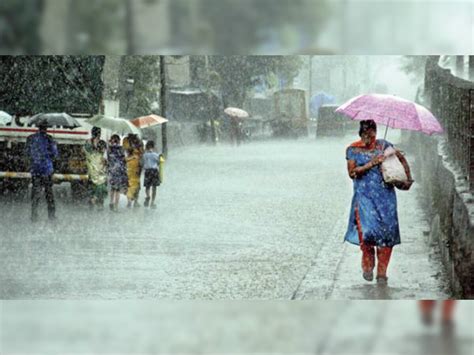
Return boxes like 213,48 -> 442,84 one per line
344,139 -> 400,247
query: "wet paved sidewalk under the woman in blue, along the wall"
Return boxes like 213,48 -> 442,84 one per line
294,177 -> 450,300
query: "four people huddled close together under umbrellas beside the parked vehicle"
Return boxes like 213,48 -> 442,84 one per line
84,127 -> 161,212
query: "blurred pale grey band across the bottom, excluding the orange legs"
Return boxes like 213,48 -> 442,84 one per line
0,301 -> 474,355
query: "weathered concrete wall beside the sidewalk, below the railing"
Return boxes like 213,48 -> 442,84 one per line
409,133 -> 474,299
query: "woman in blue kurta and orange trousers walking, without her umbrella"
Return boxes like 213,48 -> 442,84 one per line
344,120 -> 412,284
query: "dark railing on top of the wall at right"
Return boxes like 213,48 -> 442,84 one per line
424,56 -> 474,190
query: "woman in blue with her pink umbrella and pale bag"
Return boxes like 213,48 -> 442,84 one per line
336,94 -> 443,284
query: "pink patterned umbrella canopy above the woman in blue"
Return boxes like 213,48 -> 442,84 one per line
336,94 -> 443,135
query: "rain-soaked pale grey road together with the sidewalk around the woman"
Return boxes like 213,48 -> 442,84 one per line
0,137 -> 449,300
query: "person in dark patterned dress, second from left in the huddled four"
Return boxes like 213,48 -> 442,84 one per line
107,134 -> 128,212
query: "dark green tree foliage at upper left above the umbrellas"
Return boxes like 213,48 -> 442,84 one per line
0,56 -> 104,115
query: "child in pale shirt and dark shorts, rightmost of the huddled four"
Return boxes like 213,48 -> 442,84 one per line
142,141 -> 161,209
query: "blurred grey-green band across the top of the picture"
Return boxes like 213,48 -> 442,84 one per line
0,0 -> 474,54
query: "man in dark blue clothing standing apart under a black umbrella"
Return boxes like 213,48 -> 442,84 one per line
26,121 -> 58,222
